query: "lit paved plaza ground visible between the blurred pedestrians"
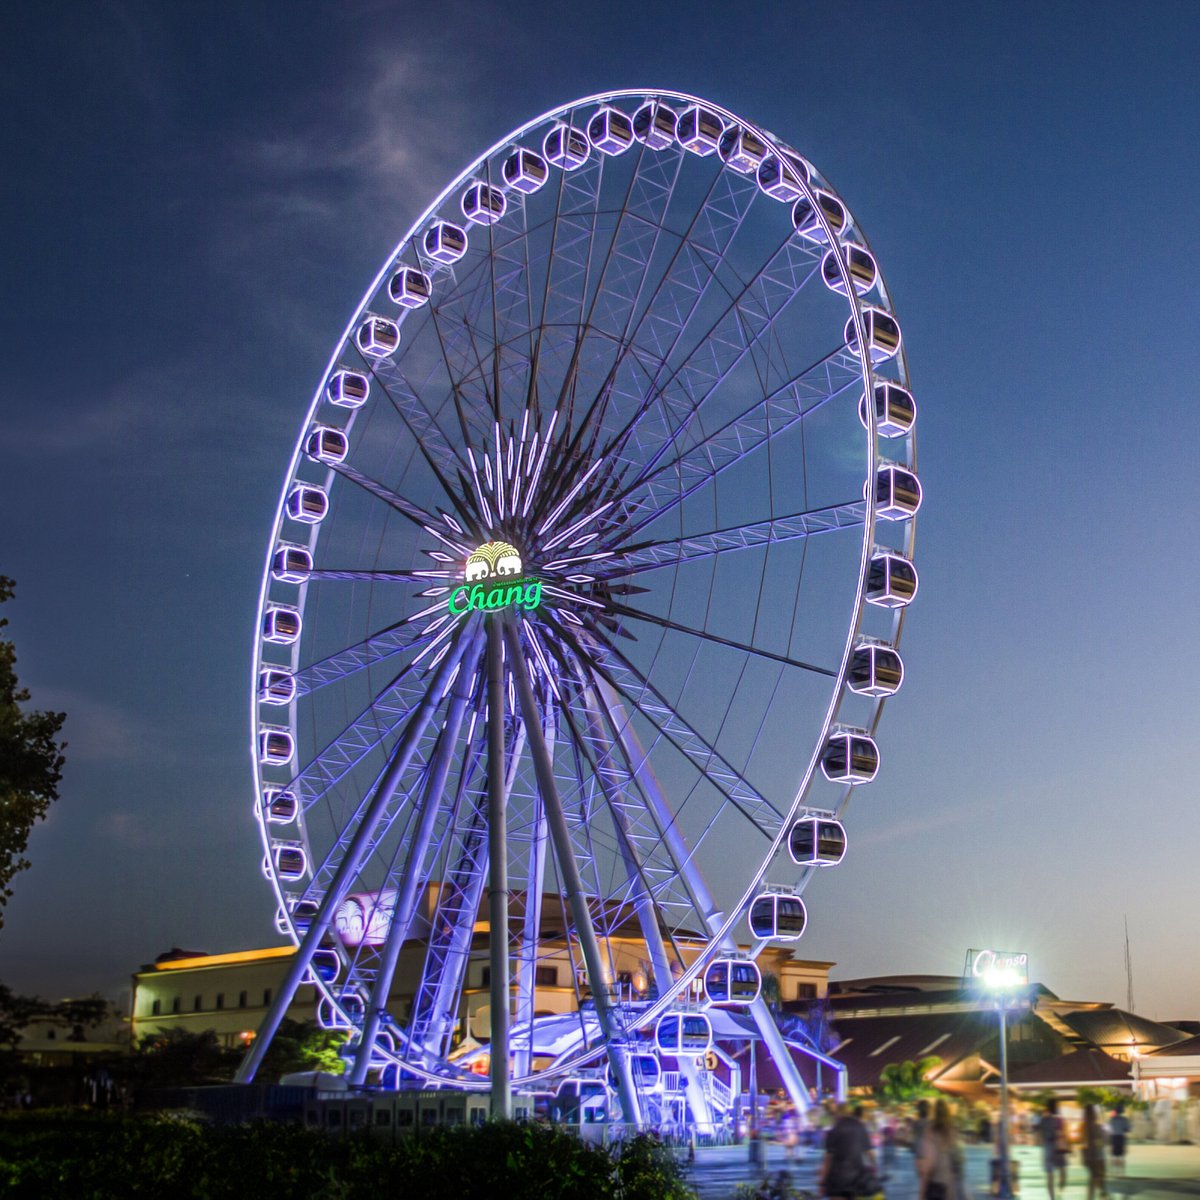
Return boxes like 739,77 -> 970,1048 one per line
690,1142 -> 1200,1200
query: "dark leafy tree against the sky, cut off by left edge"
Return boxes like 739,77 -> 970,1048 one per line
0,575 -> 66,929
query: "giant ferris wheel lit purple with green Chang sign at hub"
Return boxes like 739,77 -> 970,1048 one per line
239,91 -> 920,1121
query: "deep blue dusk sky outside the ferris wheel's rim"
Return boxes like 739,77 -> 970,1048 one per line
0,0 -> 1200,1019
